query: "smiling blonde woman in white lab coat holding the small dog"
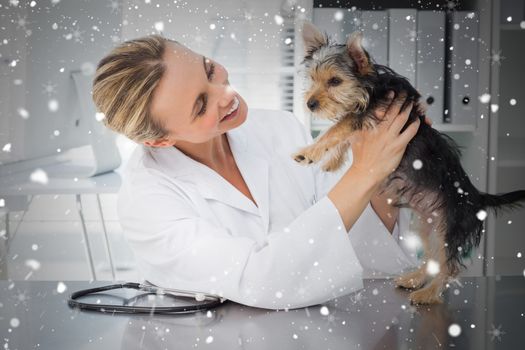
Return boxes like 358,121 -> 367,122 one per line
93,35 -> 419,309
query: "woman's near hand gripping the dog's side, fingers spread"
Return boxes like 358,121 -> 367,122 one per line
350,91 -> 420,184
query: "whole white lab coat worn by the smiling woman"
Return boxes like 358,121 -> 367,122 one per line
117,110 -> 415,309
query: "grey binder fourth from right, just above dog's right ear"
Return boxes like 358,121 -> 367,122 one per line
359,11 -> 388,65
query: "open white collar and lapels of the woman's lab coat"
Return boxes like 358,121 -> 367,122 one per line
149,122 -> 269,232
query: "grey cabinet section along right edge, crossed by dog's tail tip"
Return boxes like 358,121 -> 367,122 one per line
485,0 -> 525,275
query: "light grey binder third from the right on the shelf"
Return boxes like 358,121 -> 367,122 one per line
388,9 -> 417,86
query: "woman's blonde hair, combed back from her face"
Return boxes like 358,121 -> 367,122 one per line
93,34 -> 178,143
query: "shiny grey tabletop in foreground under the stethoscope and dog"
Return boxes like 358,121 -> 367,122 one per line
0,276 -> 525,350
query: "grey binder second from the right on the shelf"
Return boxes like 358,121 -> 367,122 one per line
415,11 -> 446,124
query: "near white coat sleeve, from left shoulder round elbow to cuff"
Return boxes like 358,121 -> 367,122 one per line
118,174 -> 363,309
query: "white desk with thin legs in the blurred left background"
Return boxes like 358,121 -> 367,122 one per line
0,168 -> 121,280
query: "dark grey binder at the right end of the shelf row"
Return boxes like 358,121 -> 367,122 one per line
445,11 -> 479,127
